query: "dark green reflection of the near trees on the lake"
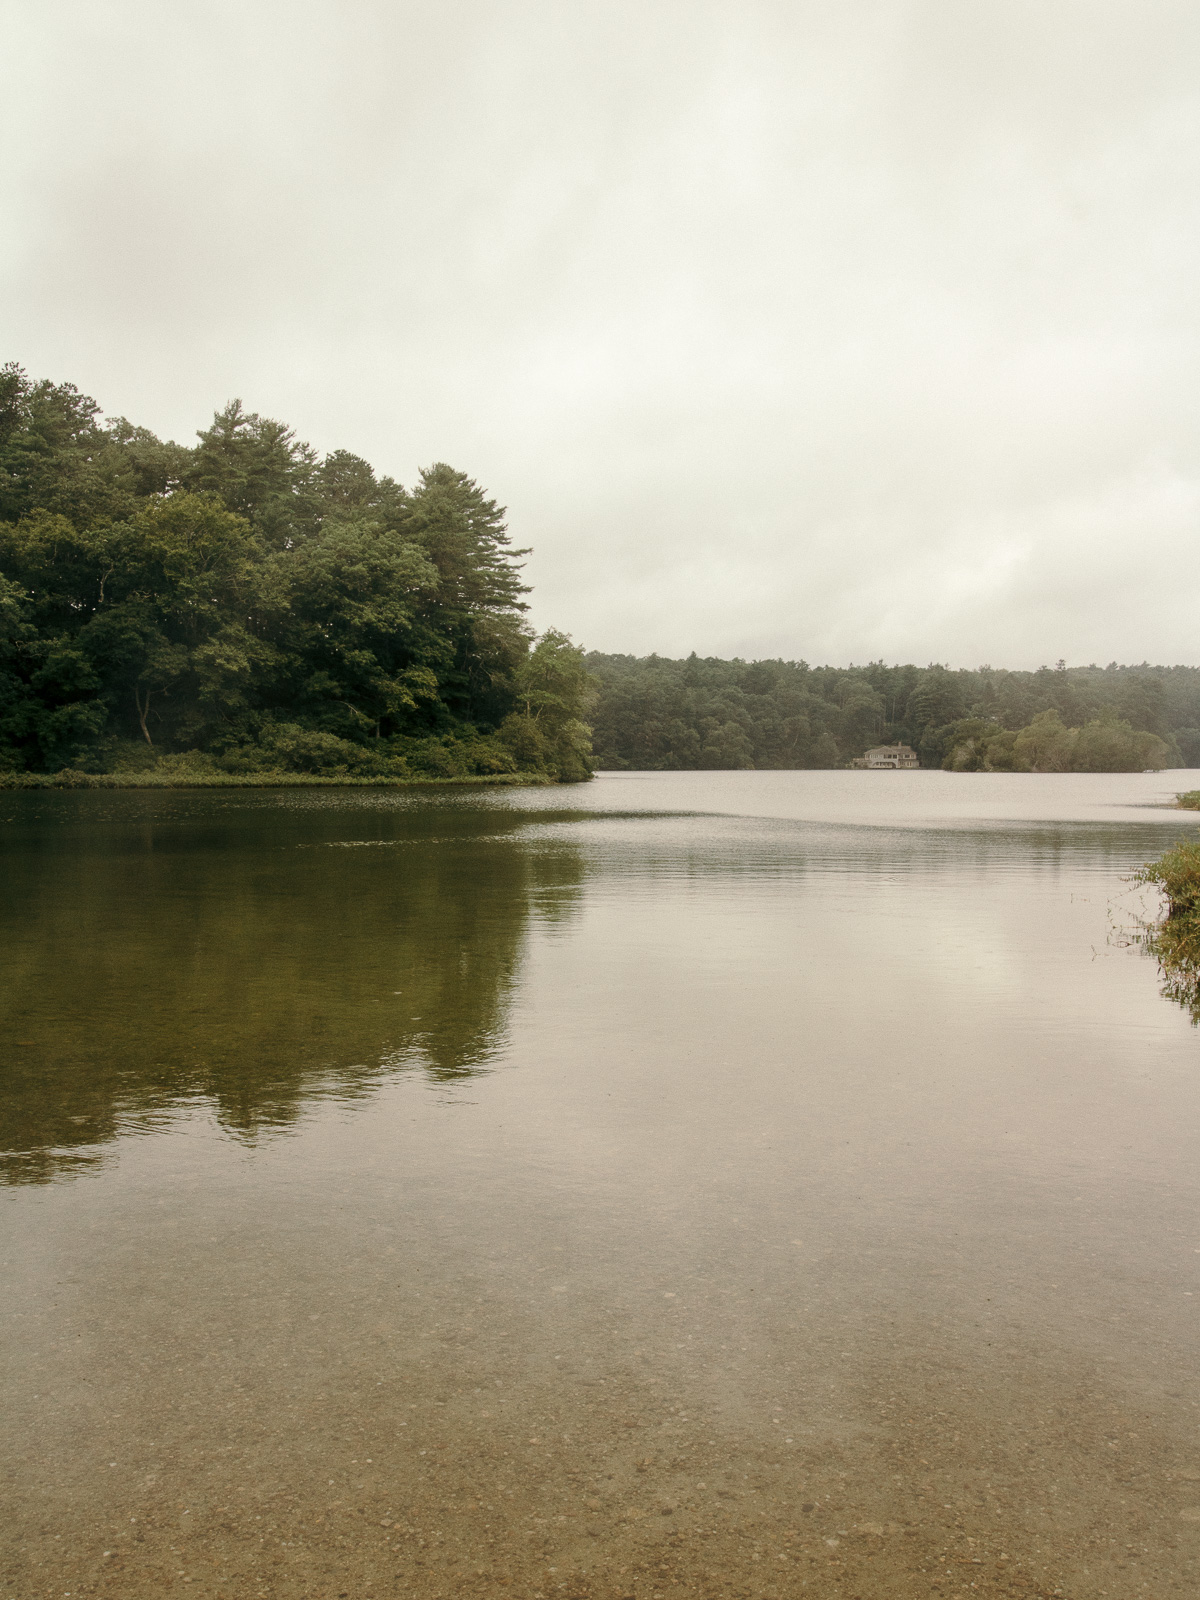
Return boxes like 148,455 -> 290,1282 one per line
0,794 -> 582,1182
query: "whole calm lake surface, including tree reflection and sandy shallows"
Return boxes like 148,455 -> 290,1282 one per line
0,773 -> 1200,1600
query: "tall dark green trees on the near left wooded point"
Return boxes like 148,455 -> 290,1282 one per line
0,365 -> 589,779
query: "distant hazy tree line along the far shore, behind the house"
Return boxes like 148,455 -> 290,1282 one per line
586,653 -> 1200,771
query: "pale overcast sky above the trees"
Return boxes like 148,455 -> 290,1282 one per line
0,0 -> 1200,666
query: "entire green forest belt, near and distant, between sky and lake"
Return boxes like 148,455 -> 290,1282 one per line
0,363 -> 1200,784
